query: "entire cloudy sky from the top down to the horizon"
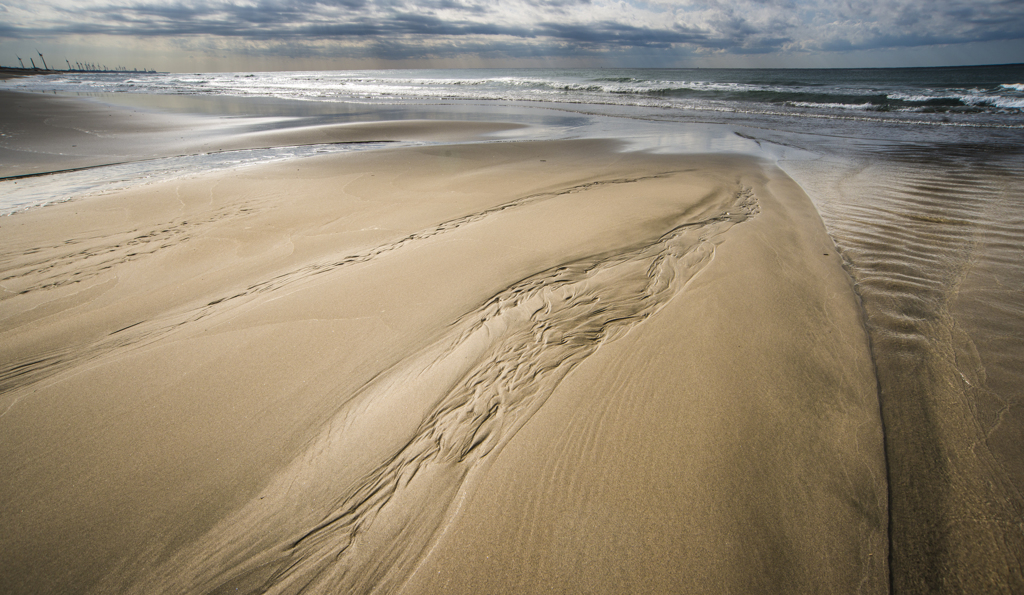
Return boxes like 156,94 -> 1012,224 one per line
0,0 -> 1024,72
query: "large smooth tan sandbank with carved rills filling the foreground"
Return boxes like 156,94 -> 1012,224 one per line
0,90 -> 889,593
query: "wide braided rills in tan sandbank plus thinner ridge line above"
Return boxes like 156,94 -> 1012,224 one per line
100,180 -> 759,593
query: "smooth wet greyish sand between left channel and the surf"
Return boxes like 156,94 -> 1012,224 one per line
0,88 -> 520,179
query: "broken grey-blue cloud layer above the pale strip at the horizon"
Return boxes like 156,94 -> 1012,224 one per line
0,0 -> 1024,65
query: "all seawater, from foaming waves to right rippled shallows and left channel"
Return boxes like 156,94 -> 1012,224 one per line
0,65 -> 1024,592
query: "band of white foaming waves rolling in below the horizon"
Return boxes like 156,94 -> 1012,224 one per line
6,69 -> 1024,127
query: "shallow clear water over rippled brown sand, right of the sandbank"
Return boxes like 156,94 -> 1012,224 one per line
784,130 -> 1024,593
